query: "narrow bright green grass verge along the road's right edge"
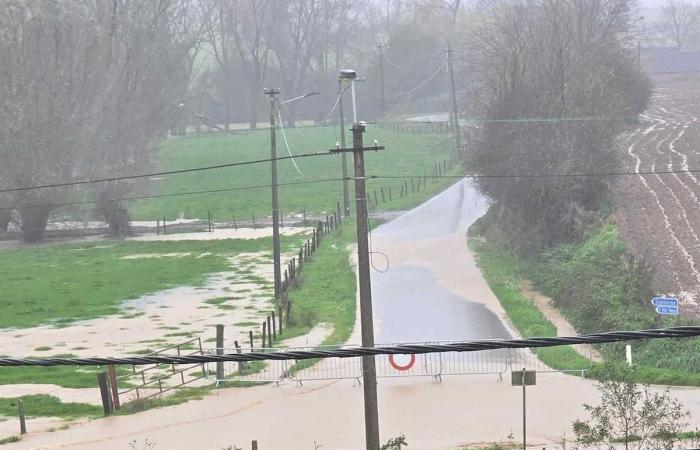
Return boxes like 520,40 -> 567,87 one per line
469,230 -> 591,370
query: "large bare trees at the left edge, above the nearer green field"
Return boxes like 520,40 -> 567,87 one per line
0,0 -> 201,241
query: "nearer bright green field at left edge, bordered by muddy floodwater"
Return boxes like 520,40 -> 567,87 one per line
0,237 -> 303,328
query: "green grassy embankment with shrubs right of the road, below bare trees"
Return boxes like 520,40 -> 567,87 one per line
470,215 -> 700,386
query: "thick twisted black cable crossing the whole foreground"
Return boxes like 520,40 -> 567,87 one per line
0,326 -> 700,367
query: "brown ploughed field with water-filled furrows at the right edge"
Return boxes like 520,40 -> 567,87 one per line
616,82 -> 700,307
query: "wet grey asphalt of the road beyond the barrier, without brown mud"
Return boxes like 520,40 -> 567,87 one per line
372,181 -> 512,344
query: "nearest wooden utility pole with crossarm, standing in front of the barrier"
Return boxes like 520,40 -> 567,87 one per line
331,123 -> 384,450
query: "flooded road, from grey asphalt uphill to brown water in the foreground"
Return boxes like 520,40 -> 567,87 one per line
7,182 -> 700,450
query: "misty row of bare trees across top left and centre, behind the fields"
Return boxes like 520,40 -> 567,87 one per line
0,0 -> 463,241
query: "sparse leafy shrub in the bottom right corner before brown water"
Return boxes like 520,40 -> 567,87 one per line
573,366 -> 690,450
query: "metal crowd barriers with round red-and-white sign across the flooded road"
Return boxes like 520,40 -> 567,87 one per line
208,341 -> 592,384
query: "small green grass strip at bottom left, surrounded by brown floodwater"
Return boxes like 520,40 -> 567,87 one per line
0,394 -> 103,419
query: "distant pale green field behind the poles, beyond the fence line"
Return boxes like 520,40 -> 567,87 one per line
128,125 -> 453,221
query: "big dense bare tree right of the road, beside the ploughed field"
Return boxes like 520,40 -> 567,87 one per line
469,0 -> 650,249
